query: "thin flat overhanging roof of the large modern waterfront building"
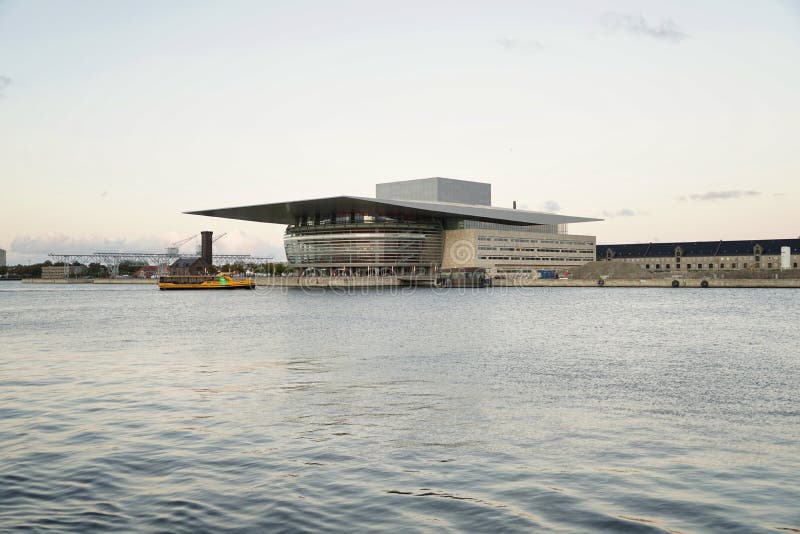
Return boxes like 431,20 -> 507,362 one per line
185,196 -> 602,224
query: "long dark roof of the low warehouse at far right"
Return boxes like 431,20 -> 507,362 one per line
597,239 -> 800,259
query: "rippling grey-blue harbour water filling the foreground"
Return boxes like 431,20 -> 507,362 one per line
0,282 -> 800,532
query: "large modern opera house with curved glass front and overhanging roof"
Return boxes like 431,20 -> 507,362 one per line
188,178 -> 598,275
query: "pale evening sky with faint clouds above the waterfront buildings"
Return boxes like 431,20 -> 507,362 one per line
0,0 -> 800,264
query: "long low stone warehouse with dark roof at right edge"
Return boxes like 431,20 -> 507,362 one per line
597,239 -> 800,272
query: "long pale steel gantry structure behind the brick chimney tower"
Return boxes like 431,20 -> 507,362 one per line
48,252 -> 273,278
